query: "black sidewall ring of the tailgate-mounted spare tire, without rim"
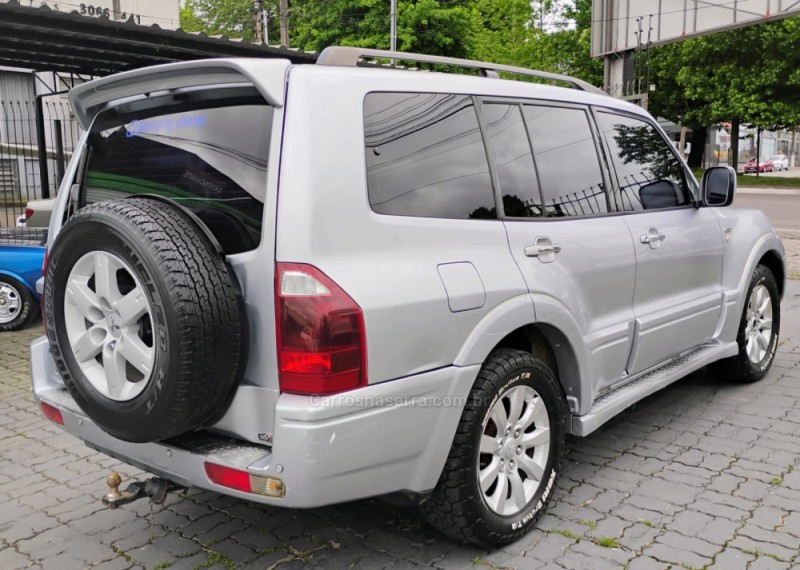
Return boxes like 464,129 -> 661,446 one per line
44,212 -> 179,440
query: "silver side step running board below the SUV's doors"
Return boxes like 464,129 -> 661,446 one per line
572,342 -> 738,436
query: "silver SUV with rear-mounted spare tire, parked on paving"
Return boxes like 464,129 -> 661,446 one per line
31,48 -> 785,545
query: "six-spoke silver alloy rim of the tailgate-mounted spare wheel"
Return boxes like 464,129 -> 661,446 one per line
64,251 -> 156,402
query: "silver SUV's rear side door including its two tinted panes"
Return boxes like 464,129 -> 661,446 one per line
482,100 -> 635,394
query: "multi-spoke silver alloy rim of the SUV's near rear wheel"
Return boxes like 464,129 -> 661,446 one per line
478,386 -> 550,516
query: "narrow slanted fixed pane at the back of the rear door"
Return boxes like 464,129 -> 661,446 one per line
483,103 -> 542,218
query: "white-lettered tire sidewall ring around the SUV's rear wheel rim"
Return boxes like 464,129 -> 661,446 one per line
470,358 -> 565,537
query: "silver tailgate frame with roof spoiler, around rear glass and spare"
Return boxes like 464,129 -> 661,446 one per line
48,59 -> 291,444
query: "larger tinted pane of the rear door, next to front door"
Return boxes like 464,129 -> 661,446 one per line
523,105 -> 608,217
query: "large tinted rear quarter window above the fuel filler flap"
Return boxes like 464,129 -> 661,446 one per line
364,93 -> 497,219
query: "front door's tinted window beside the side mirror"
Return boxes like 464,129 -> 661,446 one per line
597,113 -> 689,212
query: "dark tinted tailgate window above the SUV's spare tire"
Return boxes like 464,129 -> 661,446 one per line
83,104 -> 273,254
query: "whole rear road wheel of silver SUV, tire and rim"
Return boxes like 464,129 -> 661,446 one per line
421,349 -> 567,547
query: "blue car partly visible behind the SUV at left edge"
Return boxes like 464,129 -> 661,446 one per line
0,242 -> 45,332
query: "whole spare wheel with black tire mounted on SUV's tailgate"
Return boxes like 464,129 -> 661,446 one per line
43,198 -> 244,442
